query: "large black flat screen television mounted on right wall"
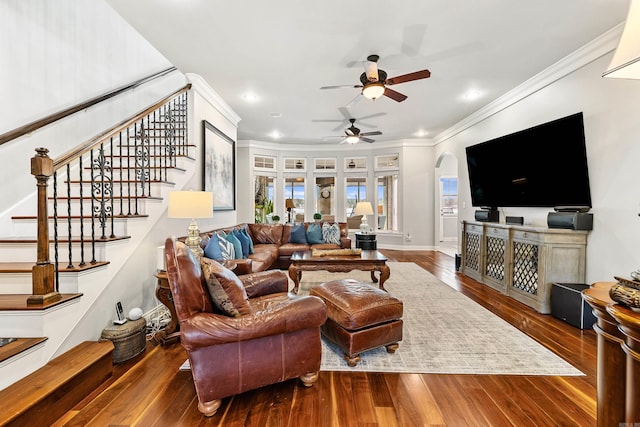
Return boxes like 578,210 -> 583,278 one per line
466,112 -> 591,211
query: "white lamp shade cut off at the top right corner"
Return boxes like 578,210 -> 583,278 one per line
602,0 -> 640,79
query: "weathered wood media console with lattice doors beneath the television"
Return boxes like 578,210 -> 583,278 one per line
461,221 -> 589,314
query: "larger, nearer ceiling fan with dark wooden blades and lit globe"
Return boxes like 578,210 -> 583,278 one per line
320,55 -> 431,102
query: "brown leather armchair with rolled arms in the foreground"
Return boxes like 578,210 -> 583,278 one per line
165,238 -> 327,416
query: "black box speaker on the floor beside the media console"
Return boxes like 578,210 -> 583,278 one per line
551,283 -> 596,329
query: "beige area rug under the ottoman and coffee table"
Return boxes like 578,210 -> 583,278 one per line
290,262 -> 584,376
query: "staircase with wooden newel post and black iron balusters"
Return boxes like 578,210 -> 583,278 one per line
0,85 -> 195,390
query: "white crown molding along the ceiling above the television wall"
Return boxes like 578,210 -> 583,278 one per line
434,22 -> 624,145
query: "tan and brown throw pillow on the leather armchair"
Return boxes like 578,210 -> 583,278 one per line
200,257 -> 253,317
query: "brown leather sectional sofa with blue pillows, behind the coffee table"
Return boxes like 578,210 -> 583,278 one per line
200,222 -> 351,274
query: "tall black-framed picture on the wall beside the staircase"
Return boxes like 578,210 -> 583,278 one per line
202,120 -> 236,211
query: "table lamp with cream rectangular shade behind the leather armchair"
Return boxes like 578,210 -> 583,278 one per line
167,191 -> 213,255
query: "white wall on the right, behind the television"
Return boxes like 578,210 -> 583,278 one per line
436,39 -> 640,283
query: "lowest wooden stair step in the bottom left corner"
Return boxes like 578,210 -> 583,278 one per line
0,341 -> 114,425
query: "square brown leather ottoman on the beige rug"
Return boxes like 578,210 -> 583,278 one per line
310,279 -> 402,366
